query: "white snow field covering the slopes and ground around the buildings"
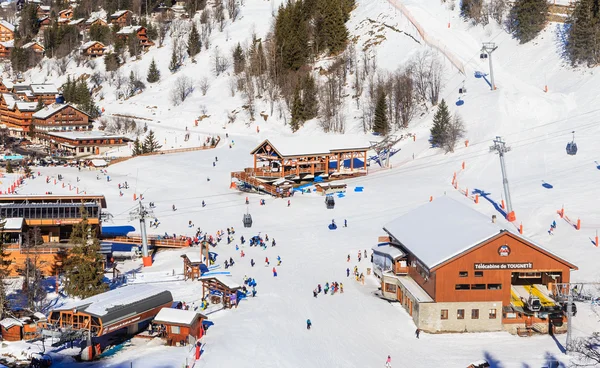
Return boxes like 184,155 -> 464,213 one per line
7,0 -> 600,367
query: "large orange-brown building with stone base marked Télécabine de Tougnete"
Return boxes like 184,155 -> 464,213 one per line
373,197 -> 577,335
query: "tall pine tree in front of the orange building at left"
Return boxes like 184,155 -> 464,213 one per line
64,206 -> 108,298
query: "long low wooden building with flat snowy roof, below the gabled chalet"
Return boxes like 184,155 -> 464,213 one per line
35,130 -> 131,157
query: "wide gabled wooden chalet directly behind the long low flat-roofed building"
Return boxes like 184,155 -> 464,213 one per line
32,103 -> 92,133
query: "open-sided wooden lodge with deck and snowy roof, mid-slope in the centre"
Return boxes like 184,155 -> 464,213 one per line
231,136 -> 371,196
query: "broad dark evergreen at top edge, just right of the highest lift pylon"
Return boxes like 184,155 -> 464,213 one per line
508,0 -> 548,44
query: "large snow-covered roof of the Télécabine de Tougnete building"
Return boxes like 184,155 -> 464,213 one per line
384,197 -> 502,269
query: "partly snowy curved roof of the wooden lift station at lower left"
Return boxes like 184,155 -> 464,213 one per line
54,284 -> 173,317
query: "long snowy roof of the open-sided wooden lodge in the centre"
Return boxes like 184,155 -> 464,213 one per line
251,135 -> 371,157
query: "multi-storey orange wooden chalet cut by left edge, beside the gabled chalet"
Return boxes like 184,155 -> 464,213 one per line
0,93 -> 37,138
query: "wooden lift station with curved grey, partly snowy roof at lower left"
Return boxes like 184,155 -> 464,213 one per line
48,284 -> 173,337
